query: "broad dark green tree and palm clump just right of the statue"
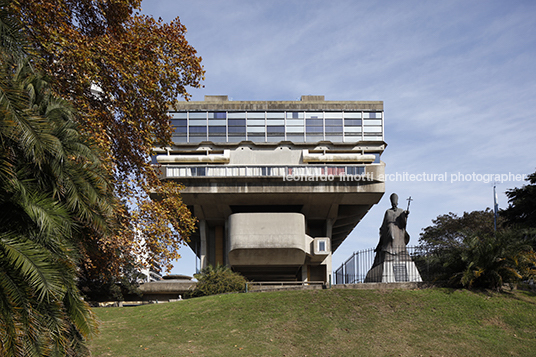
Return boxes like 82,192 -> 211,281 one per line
419,208 -> 536,290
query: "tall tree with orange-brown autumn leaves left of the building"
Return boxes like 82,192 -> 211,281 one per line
11,0 -> 204,278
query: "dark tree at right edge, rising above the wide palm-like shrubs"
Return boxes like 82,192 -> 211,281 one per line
499,172 -> 536,228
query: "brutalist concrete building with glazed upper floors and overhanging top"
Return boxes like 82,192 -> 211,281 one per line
156,96 -> 386,282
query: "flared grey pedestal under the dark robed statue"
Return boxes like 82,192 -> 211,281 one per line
365,251 -> 422,283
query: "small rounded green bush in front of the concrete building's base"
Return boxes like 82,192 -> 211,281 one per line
188,265 -> 247,297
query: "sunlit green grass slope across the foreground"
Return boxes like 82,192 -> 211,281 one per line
91,289 -> 536,357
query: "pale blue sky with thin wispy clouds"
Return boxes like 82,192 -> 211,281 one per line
142,0 -> 536,275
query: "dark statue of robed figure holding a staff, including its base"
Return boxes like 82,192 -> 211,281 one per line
365,193 -> 422,283
